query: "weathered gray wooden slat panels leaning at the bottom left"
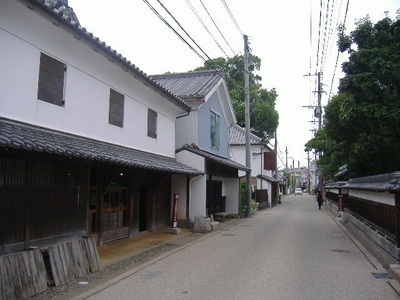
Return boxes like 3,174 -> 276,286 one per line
0,237 -> 100,300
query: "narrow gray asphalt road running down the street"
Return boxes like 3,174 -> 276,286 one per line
76,194 -> 400,300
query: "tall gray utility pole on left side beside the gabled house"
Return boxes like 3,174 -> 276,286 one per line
243,35 -> 252,217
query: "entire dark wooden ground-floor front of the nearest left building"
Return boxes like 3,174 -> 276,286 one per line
0,150 -> 171,255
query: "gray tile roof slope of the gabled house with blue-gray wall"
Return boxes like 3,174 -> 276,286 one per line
151,70 -> 223,99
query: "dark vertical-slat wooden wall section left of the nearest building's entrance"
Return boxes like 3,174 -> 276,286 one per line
0,152 -> 88,255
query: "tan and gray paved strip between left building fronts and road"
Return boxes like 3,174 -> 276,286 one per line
31,219 -> 245,300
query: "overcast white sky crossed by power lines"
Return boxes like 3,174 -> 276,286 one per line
68,0 -> 400,167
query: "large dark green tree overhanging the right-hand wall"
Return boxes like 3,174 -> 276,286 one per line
306,17 -> 400,177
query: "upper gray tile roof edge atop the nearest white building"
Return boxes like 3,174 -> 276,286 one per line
27,0 -> 191,112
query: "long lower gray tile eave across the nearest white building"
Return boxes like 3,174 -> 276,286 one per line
0,118 -> 202,175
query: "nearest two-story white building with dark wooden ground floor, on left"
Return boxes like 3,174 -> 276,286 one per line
0,0 -> 201,255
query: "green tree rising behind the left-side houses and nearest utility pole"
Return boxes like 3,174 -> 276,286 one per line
195,55 -> 279,140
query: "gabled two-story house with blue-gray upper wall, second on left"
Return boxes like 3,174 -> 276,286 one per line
152,71 -> 247,225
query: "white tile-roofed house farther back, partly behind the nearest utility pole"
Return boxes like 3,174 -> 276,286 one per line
229,124 -> 278,208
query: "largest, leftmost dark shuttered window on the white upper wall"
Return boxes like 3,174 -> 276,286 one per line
38,53 -> 67,106
